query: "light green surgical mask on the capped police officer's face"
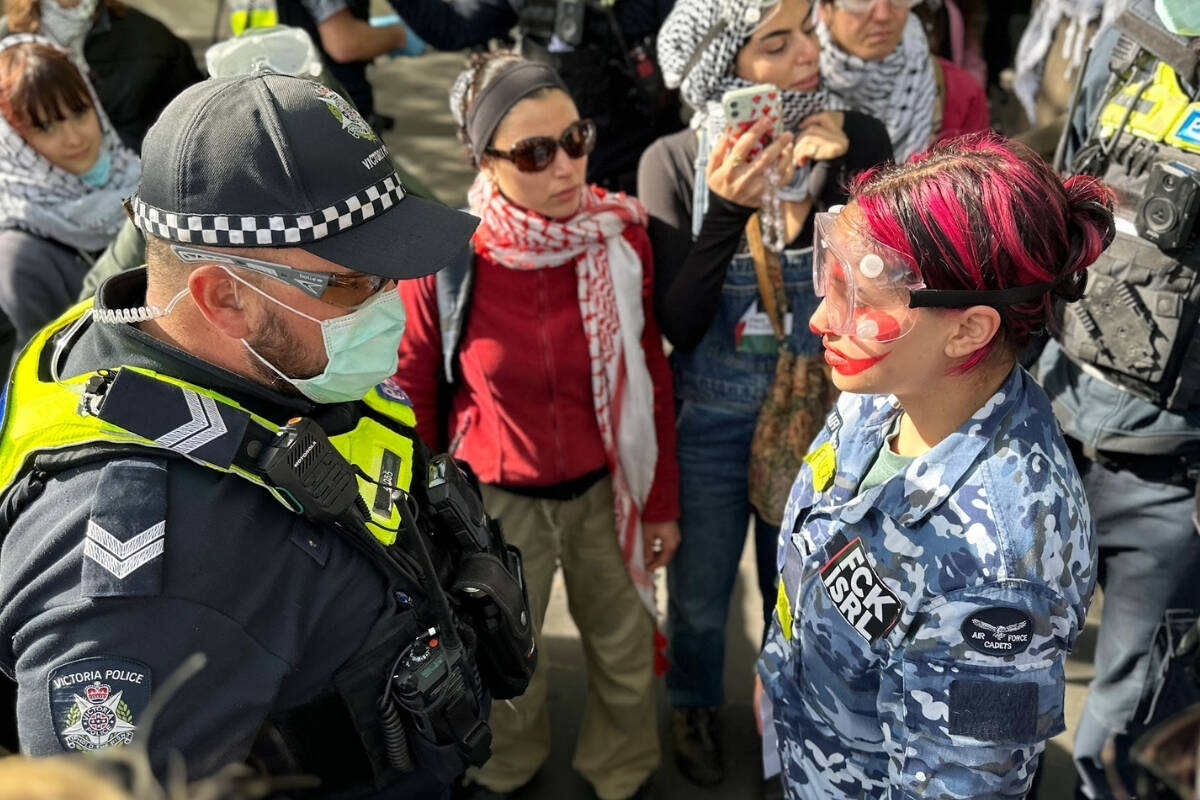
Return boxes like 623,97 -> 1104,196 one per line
224,267 -> 404,403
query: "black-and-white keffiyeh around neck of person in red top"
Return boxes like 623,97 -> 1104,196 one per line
817,14 -> 937,163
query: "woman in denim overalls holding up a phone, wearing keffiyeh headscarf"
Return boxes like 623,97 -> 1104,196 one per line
637,0 -> 892,786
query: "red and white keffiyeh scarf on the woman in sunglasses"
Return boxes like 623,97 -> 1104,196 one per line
468,173 -> 659,618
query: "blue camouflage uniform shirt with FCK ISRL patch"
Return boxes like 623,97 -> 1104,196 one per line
758,367 -> 1096,800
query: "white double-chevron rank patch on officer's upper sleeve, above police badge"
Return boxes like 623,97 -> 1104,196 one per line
83,458 -> 167,597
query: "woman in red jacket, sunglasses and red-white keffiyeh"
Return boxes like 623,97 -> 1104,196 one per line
396,53 -> 679,800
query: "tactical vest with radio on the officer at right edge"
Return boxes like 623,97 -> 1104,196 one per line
1060,18 -> 1200,410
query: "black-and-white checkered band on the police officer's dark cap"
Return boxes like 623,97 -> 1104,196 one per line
130,173 -> 404,247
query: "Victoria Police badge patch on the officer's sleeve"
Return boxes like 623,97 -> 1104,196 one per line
49,656 -> 150,751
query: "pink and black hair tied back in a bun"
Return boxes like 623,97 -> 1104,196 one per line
851,133 -> 1114,372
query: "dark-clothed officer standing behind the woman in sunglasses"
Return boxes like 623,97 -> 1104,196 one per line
390,0 -> 683,194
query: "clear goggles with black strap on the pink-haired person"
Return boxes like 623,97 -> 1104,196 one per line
812,209 -> 1054,342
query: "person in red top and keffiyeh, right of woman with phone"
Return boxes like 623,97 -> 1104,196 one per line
817,0 -> 989,162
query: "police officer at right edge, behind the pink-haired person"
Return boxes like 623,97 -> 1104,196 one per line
1038,0 -> 1200,798
